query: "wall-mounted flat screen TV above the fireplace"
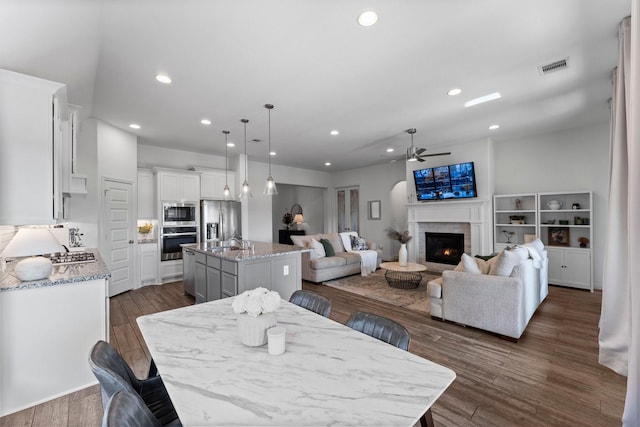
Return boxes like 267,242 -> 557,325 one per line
413,162 -> 478,202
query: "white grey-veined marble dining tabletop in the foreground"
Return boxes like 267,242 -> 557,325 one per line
138,298 -> 455,426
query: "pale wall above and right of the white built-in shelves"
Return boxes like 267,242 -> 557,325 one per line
495,122 -> 609,289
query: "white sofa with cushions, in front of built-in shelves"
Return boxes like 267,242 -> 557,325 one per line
427,240 -> 549,340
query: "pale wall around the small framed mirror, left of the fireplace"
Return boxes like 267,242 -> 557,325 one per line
328,161 -> 406,259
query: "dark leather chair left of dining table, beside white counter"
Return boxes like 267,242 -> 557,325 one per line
89,340 -> 179,425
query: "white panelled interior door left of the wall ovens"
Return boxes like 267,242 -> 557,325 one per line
103,179 -> 135,297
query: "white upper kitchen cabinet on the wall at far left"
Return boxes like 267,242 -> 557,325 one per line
0,70 -> 68,225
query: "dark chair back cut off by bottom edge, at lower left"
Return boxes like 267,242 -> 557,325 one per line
102,391 -> 162,427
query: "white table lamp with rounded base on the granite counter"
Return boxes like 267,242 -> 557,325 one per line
2,227 -> 62,281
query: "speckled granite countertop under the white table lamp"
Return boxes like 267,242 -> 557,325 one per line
0,249 -> 111,292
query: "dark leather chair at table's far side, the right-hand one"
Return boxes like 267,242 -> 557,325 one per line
347,311 -> 434,427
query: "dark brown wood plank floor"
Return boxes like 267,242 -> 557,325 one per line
0,282 -> 626,426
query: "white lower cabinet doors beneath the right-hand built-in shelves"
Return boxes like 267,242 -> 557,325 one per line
546,247 -> 592,290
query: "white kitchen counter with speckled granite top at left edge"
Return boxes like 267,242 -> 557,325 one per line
0,250 -> 110,416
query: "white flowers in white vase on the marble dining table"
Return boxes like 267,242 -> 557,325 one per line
231,287 -> 280,347
